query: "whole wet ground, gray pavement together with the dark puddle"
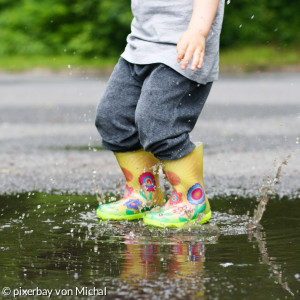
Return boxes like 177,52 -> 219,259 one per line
0,74 -> 300,299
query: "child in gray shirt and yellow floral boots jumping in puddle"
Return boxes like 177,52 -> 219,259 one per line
95,0 -> 224,227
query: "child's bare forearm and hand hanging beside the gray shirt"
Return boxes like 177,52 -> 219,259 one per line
177,0 -> 219,71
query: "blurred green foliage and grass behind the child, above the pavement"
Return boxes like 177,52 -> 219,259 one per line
0,0 -> 300,72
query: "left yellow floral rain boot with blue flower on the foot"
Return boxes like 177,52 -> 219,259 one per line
97,149 -> 164,220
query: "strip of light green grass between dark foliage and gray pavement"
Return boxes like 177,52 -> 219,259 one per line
0,46 -> 300,73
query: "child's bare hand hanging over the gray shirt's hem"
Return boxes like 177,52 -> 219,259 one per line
177,29 -> 205,71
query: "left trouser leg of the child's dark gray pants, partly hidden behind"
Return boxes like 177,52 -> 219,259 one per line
95,58 -> 142,152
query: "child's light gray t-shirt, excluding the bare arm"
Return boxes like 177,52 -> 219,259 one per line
121,0 -> 225,84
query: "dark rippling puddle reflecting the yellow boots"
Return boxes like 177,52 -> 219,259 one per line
0,193 -> 300,299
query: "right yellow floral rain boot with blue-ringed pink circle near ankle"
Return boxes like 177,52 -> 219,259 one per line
144,144 -> 211,227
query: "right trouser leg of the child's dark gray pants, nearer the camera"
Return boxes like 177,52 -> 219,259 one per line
135,64 -> 212,160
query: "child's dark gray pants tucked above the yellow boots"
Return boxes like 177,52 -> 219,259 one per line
95,58 -> 212,160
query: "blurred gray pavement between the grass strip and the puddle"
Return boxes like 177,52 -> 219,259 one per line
0,74 -> 300,196
